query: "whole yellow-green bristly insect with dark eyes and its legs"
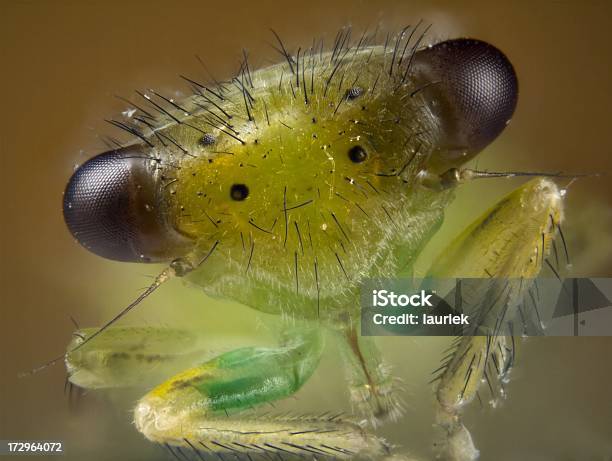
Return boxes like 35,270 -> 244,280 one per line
59,27 -> 563,460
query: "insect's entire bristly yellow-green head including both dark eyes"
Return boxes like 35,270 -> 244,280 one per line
64,33 -> 518,317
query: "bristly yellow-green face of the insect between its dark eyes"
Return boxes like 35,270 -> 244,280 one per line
150,47 -> 452,318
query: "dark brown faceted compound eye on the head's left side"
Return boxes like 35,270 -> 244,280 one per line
64,147 -> 189,262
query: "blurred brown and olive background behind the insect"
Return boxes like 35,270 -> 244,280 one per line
0,0 -> 612,461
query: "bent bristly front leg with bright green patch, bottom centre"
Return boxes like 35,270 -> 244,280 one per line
134,327 -> 387,458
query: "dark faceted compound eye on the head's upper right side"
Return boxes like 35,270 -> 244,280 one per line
415,39 -> 518,171
